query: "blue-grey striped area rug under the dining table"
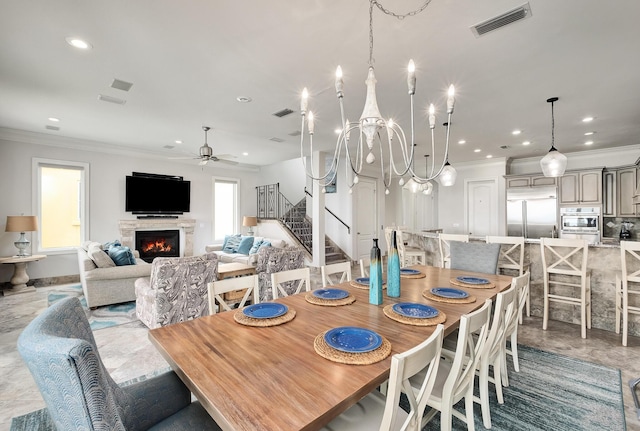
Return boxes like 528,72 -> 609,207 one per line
11,345 -> 626,431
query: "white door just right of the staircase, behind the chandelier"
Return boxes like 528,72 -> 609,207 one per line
353,177 -> 380,259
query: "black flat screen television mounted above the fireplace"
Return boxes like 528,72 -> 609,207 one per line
125,172 -> 191,214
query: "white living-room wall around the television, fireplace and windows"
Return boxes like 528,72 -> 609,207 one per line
0,130 -> 258,282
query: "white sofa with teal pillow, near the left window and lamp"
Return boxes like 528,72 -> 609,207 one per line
78,241 -> 151,308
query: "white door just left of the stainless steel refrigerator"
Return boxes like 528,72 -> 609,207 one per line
466,180 -> 498,236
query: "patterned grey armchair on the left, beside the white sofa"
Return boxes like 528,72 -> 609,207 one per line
135,253 -> 218,329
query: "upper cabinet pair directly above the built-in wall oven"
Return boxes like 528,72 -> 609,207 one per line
559,169 -> 602,205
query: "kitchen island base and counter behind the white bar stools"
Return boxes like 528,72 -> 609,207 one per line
407,232 -> 640,337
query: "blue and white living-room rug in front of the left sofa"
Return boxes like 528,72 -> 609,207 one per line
47,284 -> 138,331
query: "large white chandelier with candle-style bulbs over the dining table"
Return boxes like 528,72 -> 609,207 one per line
300,0 -> 457,194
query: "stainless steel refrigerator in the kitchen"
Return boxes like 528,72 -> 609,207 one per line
507,186 -> 558,238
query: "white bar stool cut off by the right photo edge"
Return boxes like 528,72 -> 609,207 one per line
616,241 -> 640,346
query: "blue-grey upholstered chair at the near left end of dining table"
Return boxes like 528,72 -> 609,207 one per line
18,298 -> 220,430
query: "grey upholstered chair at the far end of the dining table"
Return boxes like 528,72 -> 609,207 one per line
449,241 -> 500,274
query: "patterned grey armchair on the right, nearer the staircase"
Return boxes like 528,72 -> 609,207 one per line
256,247 -> 304,302
